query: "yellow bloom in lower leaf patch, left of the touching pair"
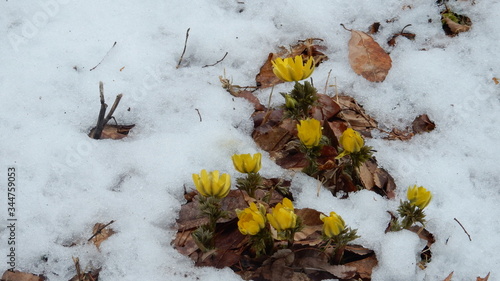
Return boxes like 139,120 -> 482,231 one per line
236,202 -> 266,235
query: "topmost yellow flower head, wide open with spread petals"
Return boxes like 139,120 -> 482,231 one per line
271,55 -> 314,82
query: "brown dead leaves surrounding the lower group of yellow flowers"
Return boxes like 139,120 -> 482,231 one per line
172,187 -> 377,281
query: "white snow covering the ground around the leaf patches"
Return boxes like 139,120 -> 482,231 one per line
0,0 -> 500,281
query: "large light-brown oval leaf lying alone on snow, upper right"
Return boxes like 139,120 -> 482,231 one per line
349,30 -> 392,82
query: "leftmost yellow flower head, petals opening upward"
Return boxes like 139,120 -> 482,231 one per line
193,169 -> 231,198
